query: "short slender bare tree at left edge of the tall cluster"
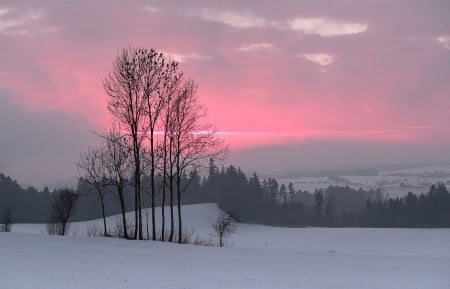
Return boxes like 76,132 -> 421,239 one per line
77,148 -> 108,236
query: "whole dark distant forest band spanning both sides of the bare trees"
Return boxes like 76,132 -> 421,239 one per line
0,161 -> 450,228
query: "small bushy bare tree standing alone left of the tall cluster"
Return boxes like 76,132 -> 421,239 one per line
48,188 -> 78,236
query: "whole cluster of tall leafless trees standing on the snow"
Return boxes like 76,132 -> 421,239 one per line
78,47 -> 226,242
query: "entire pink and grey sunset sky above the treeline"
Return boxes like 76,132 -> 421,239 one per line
0,0 -> 450,184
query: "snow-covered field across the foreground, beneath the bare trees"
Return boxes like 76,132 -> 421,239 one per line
0,204 -> 450,289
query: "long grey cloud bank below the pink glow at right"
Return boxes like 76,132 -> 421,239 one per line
227,140 -> 450,173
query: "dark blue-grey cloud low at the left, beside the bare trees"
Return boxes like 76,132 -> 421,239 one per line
0,91 -> 96,184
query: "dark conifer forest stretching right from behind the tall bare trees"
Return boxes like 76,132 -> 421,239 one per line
196,161 -> 450,228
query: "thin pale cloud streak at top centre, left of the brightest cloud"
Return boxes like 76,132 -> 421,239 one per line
184,8 -> 268,28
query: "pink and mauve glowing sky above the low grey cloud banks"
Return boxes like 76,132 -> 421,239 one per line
0,1 -> 450,153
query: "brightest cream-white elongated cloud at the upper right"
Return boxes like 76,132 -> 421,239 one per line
289,18 -> 368,37
